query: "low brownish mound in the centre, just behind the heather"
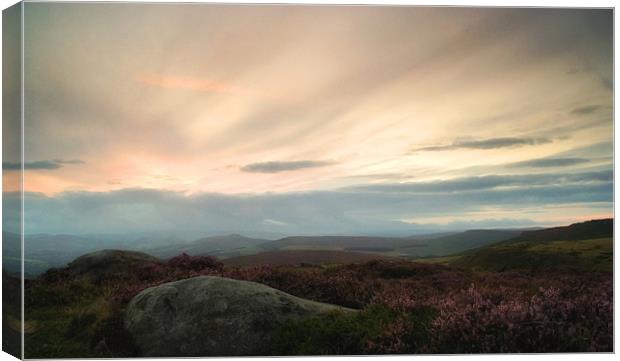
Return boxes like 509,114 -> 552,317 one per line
222,251 -> 395,266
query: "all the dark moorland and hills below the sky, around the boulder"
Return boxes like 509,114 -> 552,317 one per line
3,219 -> 613,358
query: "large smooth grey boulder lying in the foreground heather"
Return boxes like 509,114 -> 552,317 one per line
125,276 -> 353,357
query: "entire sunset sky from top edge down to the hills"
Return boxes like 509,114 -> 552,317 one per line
3,3 -> 613,234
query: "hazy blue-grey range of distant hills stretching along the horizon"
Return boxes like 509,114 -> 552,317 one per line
3,225 -> 531,276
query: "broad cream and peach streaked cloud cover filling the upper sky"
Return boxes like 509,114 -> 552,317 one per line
21,4 -> 613,198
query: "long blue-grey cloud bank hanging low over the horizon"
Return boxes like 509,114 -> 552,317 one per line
15,170 -> 613,236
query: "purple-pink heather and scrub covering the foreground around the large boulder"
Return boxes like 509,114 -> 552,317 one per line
26,254 -> 613,357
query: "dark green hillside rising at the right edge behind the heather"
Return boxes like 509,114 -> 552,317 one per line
451,219 -> 613,272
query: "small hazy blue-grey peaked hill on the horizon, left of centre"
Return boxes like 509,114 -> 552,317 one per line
147,234 -> 268,258
